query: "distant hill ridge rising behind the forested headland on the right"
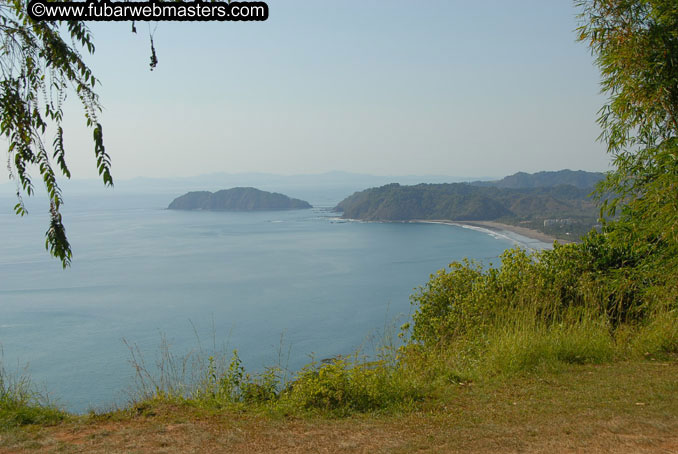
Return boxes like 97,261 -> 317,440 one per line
471,169 -> 605,189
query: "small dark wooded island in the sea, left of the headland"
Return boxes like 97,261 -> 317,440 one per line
167,188 -> 311,211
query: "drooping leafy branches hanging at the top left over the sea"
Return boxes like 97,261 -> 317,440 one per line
0,0 -> 113,268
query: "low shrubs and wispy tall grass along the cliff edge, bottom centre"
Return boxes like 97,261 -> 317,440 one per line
123,339 -> 425,416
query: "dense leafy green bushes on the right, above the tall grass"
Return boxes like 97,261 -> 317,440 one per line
412,238 -> 676,352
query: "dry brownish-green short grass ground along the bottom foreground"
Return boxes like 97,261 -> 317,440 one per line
0,358 -> 678,454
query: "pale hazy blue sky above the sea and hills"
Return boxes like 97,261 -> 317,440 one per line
5,0 -> 609,181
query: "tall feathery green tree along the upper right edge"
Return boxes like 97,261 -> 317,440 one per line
575,0 -> 678,254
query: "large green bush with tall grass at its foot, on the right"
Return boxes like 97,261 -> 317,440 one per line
412,223 -> 678,377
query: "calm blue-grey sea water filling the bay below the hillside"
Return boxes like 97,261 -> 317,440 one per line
0,195 -> 540,412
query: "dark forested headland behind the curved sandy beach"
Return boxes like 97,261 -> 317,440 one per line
335,181 -> 598,238
